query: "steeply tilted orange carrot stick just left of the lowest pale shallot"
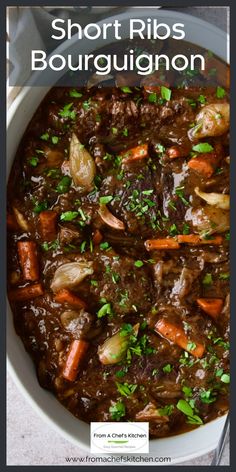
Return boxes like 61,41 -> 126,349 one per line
62,339 -> 89,382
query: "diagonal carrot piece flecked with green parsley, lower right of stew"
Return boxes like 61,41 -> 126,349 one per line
155,318 -> 205,357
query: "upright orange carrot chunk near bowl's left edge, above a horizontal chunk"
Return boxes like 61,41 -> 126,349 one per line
17,241 -> 39,282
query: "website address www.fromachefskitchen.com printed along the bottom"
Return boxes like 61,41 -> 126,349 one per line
65,455 -> 171,464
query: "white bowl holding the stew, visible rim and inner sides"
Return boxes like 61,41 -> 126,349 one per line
7,9 -> 228,465
